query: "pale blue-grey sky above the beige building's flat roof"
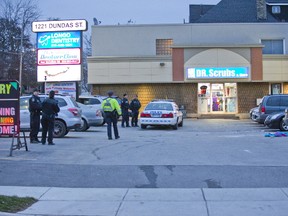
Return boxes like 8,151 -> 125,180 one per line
38,0 -> 220,27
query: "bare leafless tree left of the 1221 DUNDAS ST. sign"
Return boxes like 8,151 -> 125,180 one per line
0,0 -> 40,90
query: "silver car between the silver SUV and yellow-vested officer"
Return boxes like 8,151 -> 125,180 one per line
75,102 -> 104,131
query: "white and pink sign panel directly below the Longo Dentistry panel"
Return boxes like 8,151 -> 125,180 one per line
37,48 -> 81,65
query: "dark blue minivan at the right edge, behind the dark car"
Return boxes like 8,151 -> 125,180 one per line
256,94 -> 288,124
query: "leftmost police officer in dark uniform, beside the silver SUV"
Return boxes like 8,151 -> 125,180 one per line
29,88 -> 42,143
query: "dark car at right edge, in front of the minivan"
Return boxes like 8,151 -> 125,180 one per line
264,112 -> 288,131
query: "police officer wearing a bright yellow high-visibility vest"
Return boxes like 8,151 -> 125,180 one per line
101,91 -> 122,140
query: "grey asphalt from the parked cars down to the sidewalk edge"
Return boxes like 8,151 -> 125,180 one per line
0,119 -> 288,188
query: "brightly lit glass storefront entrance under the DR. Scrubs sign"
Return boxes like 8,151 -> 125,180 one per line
198,83 -> 237,114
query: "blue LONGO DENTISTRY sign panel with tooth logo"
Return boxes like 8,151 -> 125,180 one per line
37,31 -> 82,49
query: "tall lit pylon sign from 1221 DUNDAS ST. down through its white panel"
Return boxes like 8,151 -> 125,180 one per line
32,20 -> 87,83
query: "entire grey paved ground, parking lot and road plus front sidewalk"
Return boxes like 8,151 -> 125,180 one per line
0,119 -> 288,216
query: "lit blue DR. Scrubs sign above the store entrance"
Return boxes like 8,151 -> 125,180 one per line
187,67 -> 249,79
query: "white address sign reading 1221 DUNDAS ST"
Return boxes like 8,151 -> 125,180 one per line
32,20 -> 87,32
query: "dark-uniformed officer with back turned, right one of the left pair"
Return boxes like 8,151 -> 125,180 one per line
41,90 -> 60,145
